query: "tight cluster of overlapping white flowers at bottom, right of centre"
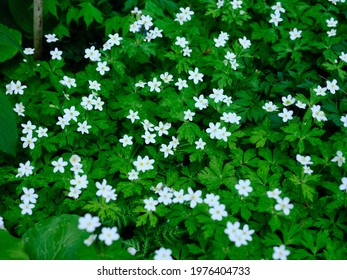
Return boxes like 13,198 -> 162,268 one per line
224,221 -> 254,247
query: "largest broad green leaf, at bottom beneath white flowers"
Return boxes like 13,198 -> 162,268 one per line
23,215 -> 88,260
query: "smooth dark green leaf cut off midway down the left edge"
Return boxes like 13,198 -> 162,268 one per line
0,94 -> 18,156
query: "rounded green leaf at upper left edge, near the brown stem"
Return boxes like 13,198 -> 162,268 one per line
0,24 -> 22,62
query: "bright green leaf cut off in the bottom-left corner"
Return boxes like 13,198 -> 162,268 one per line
0,229 -> 29,260
